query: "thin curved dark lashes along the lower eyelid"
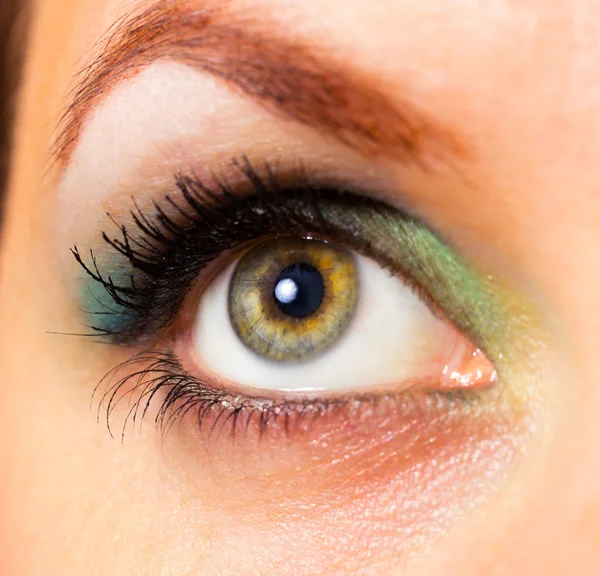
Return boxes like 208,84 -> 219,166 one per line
94,348 -> 481,440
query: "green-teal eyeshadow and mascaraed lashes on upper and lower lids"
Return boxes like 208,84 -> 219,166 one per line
73,157 -> 544,440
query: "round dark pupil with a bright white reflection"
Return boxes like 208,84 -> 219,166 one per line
273,262 -> 325,318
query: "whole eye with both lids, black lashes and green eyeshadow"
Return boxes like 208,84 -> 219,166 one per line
73,157 -> 526,441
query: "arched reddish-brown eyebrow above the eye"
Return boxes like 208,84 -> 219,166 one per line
55,0 -> 467,168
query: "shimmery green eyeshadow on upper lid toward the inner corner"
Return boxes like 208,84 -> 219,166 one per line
316,203 -> 539,376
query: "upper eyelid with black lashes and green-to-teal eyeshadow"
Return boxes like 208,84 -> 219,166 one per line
73,158 -> 532,361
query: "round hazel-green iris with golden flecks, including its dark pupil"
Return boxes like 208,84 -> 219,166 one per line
229,236 -> 359,362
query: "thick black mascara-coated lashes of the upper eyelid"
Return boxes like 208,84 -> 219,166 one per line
72,157 -> 408,342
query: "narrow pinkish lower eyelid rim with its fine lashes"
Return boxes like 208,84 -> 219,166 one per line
98,330 -> 503,442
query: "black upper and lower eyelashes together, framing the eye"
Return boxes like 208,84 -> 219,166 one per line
77,157 -> 472,436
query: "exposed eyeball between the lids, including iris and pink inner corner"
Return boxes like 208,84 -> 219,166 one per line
188,237 -> 496,394
